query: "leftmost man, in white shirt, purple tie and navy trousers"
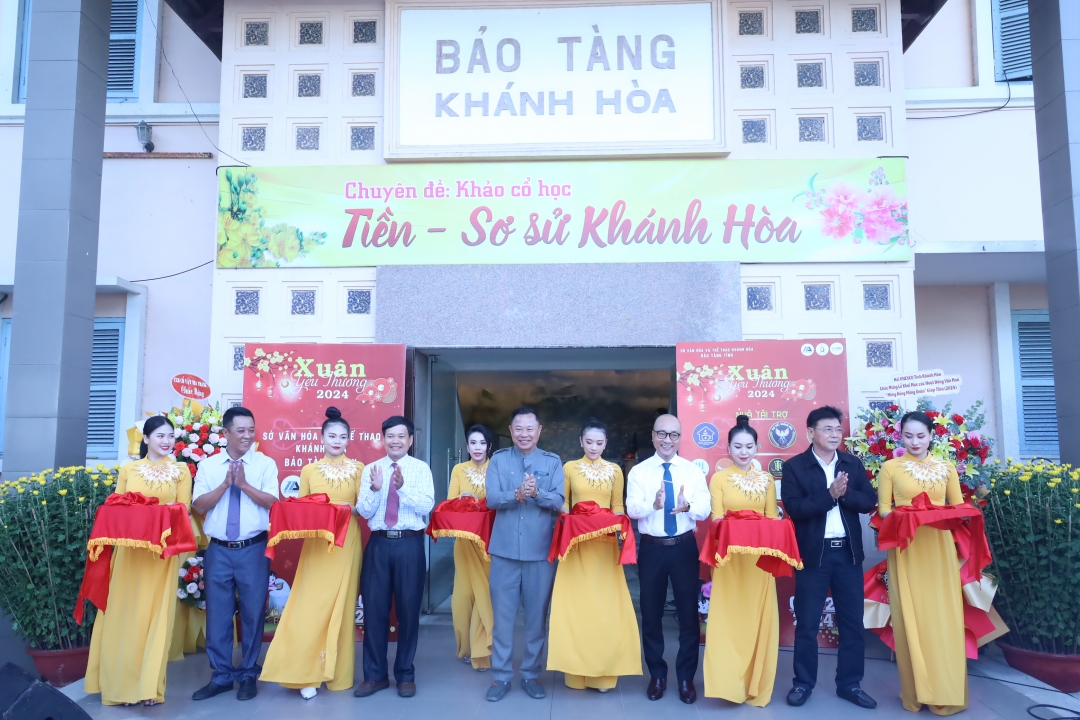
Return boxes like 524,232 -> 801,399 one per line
191,407 -> 278,699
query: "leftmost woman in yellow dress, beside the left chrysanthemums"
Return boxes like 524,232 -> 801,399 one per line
85,416 -> 191,705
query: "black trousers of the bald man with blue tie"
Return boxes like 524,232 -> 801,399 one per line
637,532 -> 701,681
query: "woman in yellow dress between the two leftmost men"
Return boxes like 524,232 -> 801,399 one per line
259,407 -> 364,699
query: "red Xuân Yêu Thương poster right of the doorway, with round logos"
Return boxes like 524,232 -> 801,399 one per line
675,338 -> 849,647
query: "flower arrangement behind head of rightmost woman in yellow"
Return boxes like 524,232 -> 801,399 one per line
845,399 -> 994,495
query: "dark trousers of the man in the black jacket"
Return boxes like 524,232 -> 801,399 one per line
794,540 -> 865,690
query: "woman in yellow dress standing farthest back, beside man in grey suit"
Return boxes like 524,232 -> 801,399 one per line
446,425 -> 495,673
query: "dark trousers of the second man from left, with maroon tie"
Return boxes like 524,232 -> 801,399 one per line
360,533 -> 427,682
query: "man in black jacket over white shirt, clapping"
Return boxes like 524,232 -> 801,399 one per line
780,405 -> 877,708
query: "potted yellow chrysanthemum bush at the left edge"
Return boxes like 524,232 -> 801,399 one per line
0,465 -> 117,687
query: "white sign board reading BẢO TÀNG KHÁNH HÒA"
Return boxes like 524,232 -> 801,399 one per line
386,0 -> 723,159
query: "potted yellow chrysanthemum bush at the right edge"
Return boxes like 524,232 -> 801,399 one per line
983,458 -> 1080,693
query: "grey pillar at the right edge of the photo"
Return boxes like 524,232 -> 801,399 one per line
1028,0 -> 1080,466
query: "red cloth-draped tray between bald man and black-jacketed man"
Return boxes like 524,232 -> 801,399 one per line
698,510 -> 802,578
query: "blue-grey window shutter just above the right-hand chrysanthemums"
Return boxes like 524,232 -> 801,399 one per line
1014,312 -> 1058,457
